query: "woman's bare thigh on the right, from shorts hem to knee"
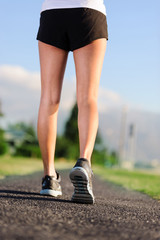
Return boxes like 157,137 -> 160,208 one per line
73,38 -> 106,103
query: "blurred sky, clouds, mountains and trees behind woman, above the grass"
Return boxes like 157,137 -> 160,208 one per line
0,0 -> 160,171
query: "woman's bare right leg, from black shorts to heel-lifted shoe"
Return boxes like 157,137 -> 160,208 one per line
73,39 -> 106,165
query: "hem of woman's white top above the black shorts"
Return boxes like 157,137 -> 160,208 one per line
41,0 -> 106,15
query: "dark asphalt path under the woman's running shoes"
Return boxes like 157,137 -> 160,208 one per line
0,171 -> 160,240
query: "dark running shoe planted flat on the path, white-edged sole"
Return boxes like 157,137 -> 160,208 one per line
40,173 -> 62,197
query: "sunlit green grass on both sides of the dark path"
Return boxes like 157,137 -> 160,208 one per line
0,155 -> 160,199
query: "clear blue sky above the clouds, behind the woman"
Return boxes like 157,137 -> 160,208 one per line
0,0 -> 160,113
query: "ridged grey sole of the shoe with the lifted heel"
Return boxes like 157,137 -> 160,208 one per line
69,167 -> 94,204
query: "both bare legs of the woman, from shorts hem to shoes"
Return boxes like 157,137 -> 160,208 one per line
37,38 -> 106,176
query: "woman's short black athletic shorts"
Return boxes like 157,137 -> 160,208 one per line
37,8 -> 108,51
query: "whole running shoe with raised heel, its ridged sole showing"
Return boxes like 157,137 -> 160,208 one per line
69,158 -> 94,204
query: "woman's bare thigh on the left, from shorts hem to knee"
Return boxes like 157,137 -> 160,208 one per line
38,41 -> 68,102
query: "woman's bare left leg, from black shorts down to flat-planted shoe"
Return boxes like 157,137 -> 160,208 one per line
37,41 -> 68,176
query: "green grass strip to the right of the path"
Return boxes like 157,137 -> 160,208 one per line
93,166 -> 160,199
